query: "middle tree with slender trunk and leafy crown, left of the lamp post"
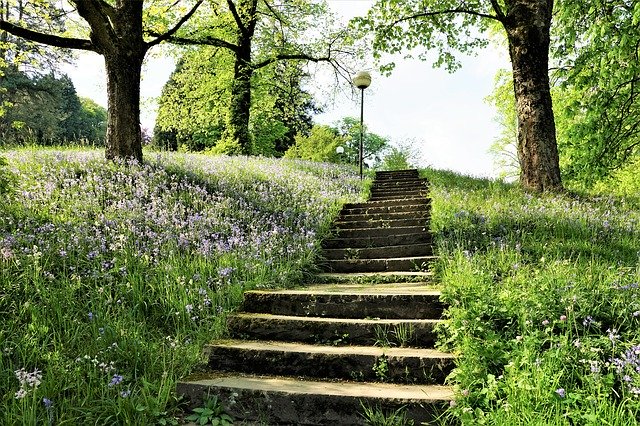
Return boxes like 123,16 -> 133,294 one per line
162,0 -> 355,154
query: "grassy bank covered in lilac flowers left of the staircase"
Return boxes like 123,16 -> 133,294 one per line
0,150 -> 362,425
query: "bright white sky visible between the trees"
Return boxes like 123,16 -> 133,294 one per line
63,0 -> 509,177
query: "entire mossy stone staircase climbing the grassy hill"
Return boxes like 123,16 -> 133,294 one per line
178,170 -> 453,425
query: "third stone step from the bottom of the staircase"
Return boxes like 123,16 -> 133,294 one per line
228,313 -> 441,348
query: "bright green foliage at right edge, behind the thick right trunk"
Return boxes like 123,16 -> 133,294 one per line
552,0 -> 640,186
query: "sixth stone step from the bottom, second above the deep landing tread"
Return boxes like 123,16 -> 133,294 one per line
321,256 -> 436,272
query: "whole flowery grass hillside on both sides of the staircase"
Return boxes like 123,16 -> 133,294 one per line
0,150 -> 640,426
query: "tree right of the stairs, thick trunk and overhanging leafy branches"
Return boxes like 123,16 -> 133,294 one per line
355,0 -> 562,191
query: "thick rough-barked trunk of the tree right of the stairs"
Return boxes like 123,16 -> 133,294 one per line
504,0 -> 562,191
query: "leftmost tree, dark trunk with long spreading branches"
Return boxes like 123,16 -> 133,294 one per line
0,0 -> 204,161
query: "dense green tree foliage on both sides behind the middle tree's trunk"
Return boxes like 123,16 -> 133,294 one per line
154,46 -> 319,156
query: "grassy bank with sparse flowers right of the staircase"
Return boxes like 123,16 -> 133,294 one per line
424,170 -> 640,426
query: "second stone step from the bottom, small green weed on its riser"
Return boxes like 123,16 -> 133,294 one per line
205,340 -> 454,385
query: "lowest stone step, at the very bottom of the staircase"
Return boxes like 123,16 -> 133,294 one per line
177,374 -> 454,426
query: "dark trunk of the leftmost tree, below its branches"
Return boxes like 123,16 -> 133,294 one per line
104,52 -> 144,161
